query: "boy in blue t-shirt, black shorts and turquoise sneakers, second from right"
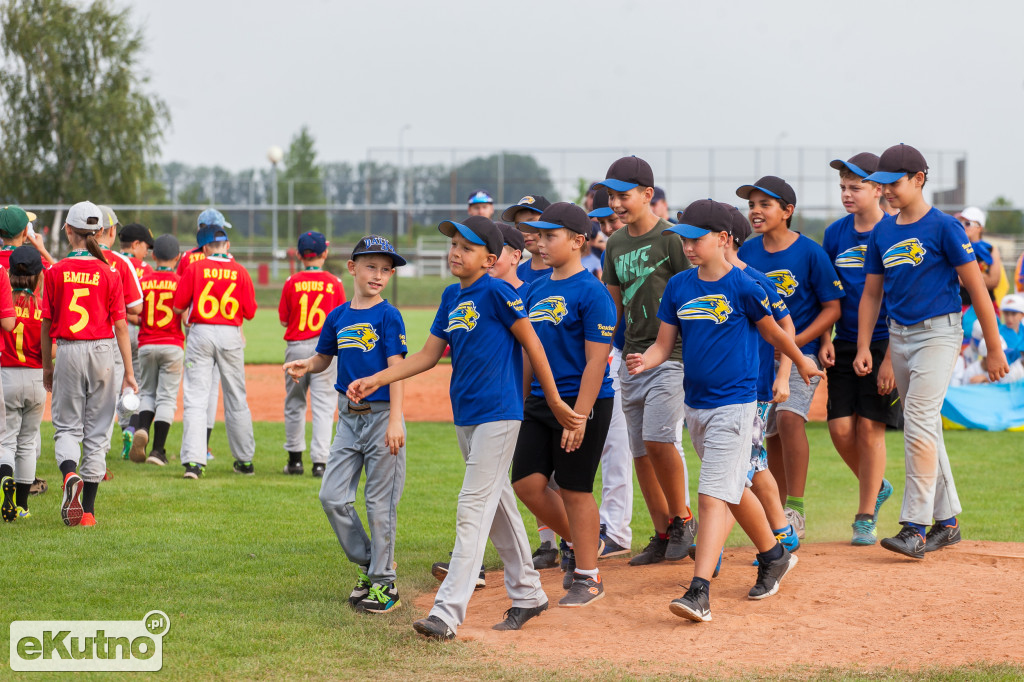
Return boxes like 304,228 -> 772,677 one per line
818,152 -> 901,546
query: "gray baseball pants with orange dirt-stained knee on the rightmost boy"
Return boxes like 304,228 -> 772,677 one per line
889,312 -> 964,525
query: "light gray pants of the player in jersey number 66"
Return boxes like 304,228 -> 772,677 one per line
181,324 -> 256,465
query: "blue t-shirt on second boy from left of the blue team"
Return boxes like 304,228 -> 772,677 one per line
430,274 -> 526,426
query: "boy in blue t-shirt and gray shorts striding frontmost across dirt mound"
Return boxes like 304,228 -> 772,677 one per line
626,199 -> 822,622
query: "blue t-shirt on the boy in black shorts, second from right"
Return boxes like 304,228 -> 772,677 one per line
821,213 -> 889,343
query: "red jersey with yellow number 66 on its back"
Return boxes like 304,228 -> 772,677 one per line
174,256 -> 256,327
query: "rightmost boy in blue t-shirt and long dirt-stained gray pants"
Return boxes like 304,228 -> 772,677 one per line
853,144 -> 1009,559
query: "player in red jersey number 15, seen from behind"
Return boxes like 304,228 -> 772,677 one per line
126,228 -> 185,466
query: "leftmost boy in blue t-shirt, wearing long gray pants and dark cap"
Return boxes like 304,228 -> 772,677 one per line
284,236 -> 407,613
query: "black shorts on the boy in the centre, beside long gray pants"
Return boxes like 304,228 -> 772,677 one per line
512,395 -> 614,493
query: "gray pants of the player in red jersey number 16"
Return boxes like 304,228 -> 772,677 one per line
285,337 -> 335,464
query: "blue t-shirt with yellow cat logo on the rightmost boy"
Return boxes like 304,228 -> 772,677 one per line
864,208 -> 975,325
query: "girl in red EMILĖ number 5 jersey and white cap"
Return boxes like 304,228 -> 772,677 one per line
41,202 -> 138,525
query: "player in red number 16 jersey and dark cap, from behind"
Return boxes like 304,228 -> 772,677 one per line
278,231 -> 345,478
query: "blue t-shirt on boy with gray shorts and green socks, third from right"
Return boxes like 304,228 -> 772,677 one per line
739,235 -> 844,355
